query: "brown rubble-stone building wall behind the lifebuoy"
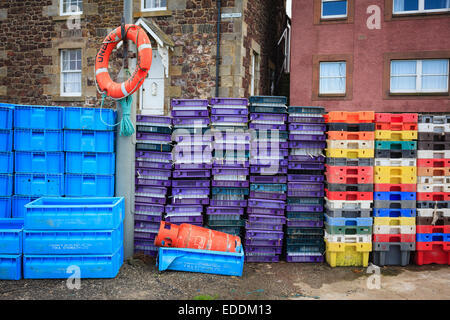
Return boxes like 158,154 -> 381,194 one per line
0,0 -> 286,113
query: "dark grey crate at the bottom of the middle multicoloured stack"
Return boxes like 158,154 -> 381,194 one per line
372,242 -> 416,266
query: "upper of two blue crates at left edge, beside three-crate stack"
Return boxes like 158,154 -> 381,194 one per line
0,219 -> 24,254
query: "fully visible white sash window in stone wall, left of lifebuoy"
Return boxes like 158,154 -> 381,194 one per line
61,49 -> 81,97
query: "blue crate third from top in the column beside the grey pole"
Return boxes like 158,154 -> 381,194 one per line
66,152 -> 116,175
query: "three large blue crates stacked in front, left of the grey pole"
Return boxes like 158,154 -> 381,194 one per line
23,197 -> 125,279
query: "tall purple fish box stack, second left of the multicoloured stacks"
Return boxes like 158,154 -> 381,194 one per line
245,96 -> 288,262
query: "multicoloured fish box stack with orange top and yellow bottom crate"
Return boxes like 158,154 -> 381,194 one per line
325,111 -> 375,267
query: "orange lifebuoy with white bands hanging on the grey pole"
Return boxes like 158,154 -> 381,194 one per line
95,24 -> 152,99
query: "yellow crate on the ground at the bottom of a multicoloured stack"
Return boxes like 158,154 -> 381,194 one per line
325,240 -> 372,268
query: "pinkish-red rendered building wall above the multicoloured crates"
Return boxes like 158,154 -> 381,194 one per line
290,0 -> 450,112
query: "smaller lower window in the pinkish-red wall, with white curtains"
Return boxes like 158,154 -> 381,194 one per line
319,61 -> 347,94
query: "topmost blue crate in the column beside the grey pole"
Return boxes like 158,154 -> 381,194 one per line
64,107 -> 117,131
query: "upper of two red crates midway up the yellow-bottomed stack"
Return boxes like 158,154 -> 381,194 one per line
325,165 -> 374,184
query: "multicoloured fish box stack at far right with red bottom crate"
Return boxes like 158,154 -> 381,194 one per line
416,115 -> 450,265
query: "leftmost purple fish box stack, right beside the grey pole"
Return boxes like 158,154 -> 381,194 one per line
134,115 -> 172,256
